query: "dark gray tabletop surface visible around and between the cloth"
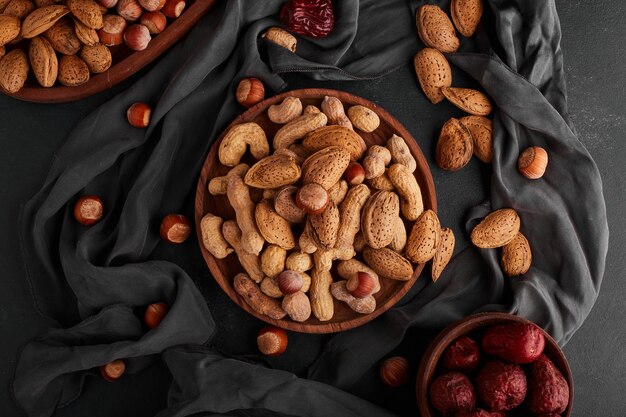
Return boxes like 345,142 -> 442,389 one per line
0,0 -> 626,417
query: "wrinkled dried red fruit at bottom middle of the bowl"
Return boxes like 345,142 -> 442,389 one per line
476,360 -> 526,411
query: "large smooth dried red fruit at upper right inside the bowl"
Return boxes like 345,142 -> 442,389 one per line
481,323 -> 545,364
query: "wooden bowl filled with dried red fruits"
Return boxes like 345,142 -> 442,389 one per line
417,313 -> 574,417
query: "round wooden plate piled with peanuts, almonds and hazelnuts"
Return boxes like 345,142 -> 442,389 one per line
195,89 -> 438,333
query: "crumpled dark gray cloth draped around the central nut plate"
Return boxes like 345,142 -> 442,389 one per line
13,0 -> 608,417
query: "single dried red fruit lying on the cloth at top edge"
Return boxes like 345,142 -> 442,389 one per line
280,0 -> 335,38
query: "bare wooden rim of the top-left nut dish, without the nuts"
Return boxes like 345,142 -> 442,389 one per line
5,0 -> 216,103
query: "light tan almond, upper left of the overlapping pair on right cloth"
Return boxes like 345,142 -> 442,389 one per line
471,208 -> 520,248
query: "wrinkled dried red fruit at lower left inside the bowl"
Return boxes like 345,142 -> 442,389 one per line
430,372 -> 476,414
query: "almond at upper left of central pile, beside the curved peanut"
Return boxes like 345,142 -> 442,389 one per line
244,154 -> 301,189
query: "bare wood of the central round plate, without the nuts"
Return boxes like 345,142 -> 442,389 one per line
195,89 -> 437,333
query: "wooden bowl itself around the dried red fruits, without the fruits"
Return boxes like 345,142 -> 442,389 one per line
417,313 -> 574,417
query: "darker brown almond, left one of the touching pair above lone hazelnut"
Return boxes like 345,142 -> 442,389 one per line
435,118 -> 474,171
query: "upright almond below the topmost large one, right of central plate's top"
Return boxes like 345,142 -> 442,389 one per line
413,48 -> 452,104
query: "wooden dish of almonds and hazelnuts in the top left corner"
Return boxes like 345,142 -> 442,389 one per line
0,0 -> 215,103
